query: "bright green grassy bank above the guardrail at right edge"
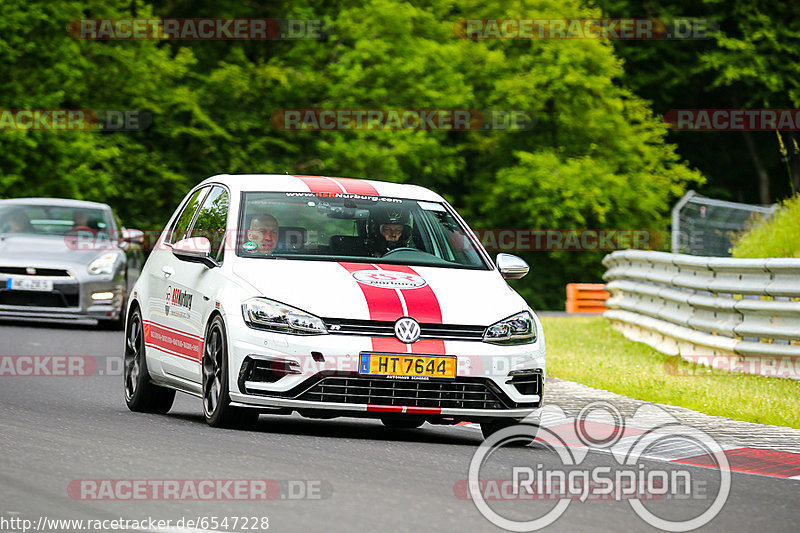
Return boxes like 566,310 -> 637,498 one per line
732,194 -> 800,257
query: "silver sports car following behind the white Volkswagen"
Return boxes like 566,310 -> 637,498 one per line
0,198 -> 143,329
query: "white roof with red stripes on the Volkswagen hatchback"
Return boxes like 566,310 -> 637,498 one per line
197,174 -> 444,202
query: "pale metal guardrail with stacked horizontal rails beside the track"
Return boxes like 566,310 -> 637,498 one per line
603,250 -> 800,377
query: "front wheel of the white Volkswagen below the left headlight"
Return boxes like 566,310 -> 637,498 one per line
202,315 -> 259,428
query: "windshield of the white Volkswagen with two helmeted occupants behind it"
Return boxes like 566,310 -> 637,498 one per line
237,192 -> 488,269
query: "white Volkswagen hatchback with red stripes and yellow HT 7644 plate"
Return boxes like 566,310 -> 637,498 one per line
124,175 -> 545,436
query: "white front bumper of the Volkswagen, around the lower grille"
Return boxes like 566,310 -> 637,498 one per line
229,326 -> 546,423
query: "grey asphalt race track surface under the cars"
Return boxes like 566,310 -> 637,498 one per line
0,322 -> 800,533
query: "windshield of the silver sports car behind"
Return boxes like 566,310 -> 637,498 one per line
0,204 -> 112,236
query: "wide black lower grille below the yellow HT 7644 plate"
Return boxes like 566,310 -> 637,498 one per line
297,377 -> 506,409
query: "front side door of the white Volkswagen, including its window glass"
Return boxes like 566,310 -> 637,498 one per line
159,185 -> 230,383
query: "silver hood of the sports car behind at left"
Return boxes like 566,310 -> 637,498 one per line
0,233 -> 119,268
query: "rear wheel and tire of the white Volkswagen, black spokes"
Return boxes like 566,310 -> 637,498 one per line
122,308 -> 175,414
